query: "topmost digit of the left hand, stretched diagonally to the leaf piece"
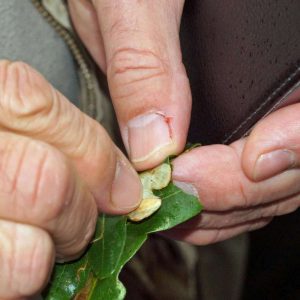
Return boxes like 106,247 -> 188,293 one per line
0,61 -> 141,213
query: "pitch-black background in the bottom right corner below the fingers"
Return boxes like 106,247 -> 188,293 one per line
242,210 -> 300,300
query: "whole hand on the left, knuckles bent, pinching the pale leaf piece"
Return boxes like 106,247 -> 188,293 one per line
0,61 -> 141,299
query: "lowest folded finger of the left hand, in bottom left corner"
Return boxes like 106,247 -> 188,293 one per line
0,223 -> 53,298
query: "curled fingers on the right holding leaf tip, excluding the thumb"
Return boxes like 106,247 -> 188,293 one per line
167,101 -> 300,245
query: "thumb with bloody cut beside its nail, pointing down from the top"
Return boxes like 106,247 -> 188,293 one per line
69,0 -> 191,170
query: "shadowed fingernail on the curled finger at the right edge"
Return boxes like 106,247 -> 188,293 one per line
253,150 -> 296,181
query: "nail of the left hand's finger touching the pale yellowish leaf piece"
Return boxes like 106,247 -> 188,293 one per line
111,158 -> 142,213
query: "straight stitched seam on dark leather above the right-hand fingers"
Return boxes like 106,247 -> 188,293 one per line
223,67 -> 300,144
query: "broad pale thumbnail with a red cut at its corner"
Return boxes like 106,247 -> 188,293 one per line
128,113 -> 172,162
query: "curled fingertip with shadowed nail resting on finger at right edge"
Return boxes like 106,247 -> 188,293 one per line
242,103 -> 300,181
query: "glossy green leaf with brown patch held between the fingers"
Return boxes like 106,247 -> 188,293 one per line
45,161 -> 202,300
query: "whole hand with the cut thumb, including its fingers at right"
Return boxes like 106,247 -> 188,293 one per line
69,0 -> 300,245
